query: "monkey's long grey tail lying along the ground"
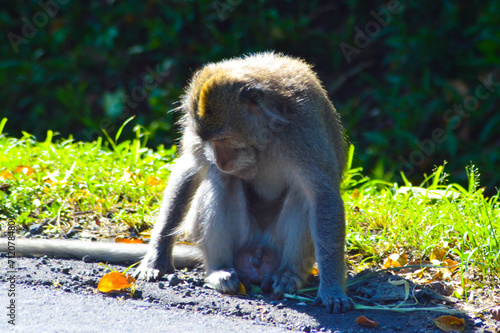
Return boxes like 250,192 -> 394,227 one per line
0,238 -> 201,268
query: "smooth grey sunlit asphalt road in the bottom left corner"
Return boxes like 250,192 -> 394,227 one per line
0,283 -> 290,333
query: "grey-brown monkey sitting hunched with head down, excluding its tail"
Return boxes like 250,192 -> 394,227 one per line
135,52 -> 353,312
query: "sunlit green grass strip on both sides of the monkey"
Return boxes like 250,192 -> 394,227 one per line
0,116 -> 500,294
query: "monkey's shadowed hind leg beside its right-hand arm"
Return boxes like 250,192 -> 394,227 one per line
262,190 -> 316,298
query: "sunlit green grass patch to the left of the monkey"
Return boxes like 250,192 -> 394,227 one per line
0,116 -> 175,233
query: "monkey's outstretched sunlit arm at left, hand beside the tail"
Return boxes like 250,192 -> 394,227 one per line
134,155 -> 200,281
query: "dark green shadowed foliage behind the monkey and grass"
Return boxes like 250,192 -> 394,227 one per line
0,0 -> 500,188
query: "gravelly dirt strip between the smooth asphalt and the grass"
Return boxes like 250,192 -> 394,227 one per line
0,253 -> 500,332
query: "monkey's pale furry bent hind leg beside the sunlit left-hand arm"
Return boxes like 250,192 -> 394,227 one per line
192,167 -> 250,293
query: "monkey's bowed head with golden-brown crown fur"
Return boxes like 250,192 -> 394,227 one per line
185,67 -> 276,179
